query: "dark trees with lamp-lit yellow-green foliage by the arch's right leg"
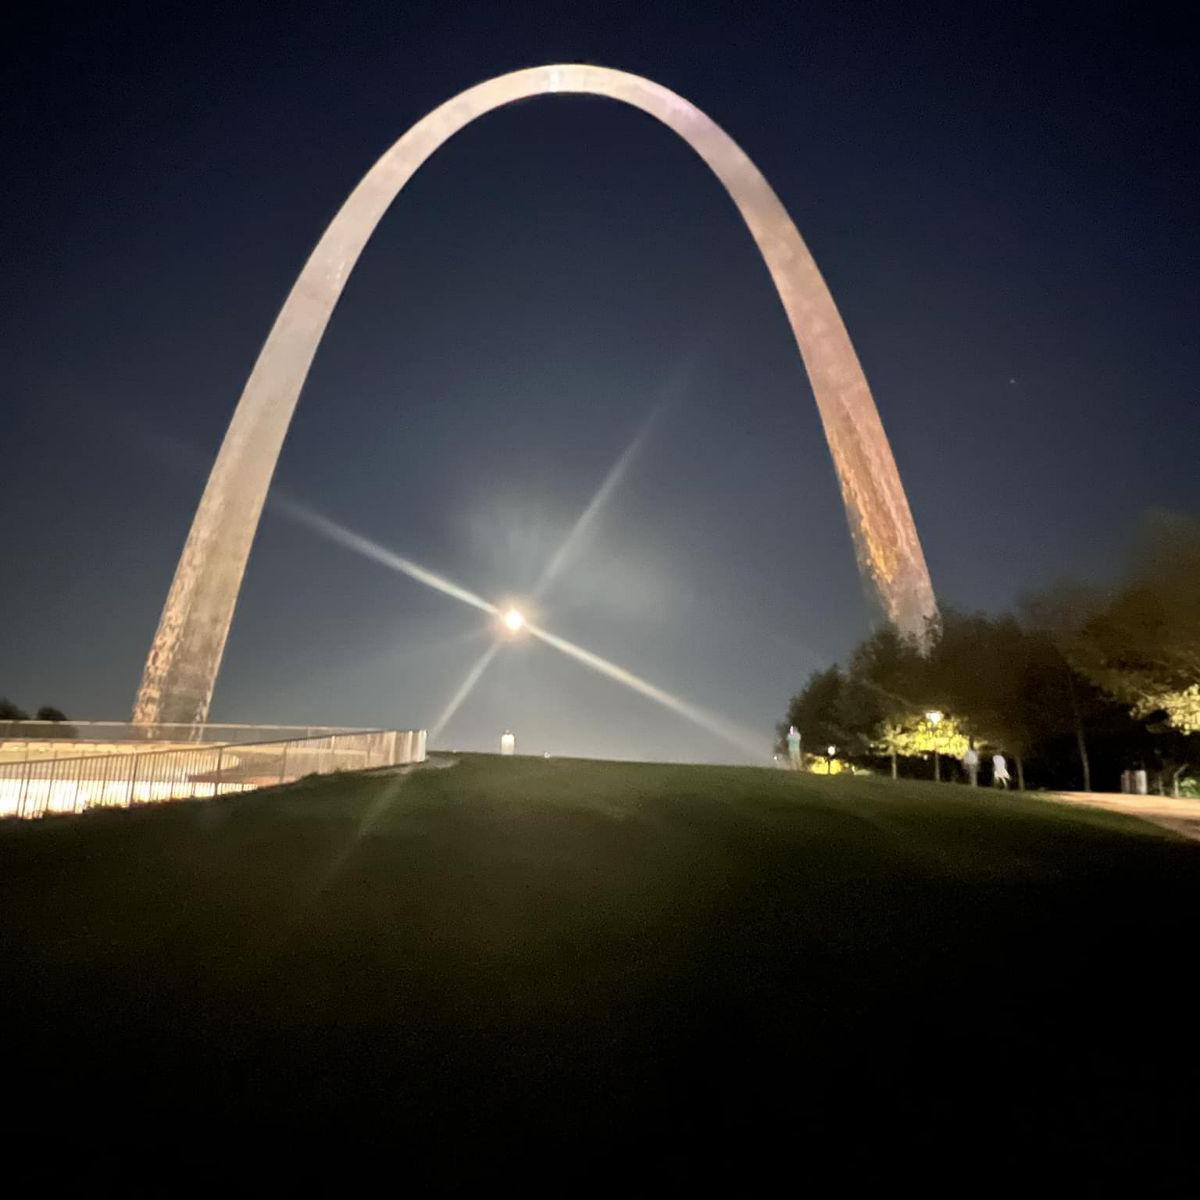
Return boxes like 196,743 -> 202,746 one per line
779,514 -> 1200,794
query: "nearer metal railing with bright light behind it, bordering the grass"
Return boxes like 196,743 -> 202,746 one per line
0,730 -> 425,817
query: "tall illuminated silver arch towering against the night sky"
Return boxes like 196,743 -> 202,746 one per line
133,65 -> 937,722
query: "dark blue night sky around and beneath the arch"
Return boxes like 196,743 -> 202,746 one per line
0,4 -> 1200,758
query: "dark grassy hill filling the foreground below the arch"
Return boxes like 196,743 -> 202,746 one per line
0,756 -> 1200,1195
